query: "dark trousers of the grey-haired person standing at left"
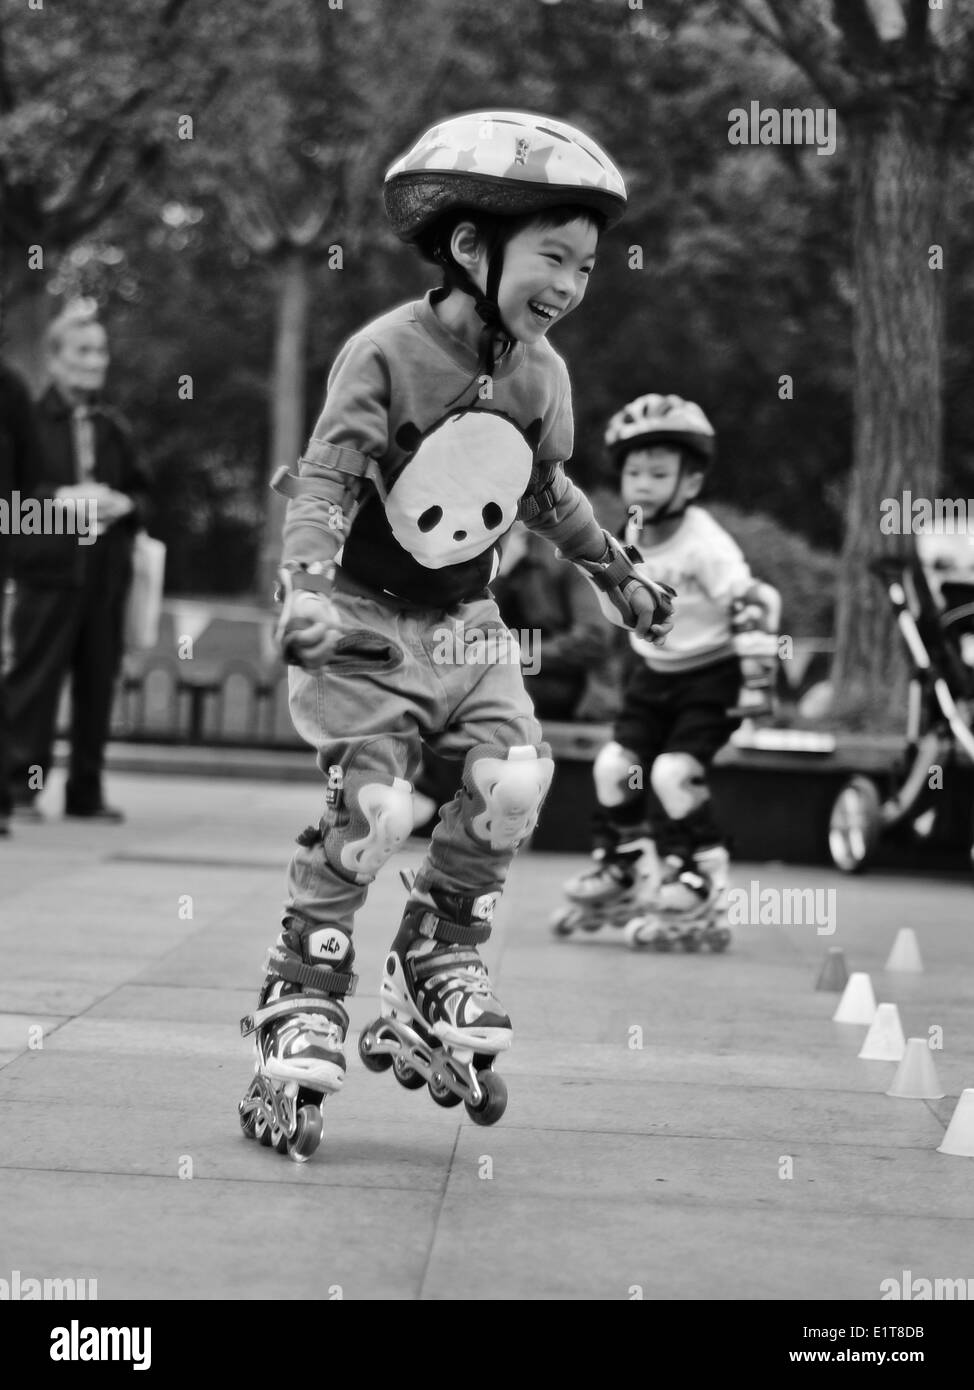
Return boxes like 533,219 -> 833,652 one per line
7,548 -> 129,810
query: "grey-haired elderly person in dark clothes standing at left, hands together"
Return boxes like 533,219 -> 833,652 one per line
7,304 -> 147,821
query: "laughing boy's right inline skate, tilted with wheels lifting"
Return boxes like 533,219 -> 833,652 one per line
358,874 -> 513,1125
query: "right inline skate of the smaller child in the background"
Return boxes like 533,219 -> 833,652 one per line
625,845 -> 731,951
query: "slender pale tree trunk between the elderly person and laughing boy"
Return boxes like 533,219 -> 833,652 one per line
257,247 -> 311,600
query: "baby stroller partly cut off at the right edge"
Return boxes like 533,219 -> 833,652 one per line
828,534 -> 974,873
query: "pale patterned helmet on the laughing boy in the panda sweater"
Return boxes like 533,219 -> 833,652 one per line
382,111 -> 627,242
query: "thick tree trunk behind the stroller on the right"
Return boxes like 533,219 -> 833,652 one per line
834,104 -> 946,727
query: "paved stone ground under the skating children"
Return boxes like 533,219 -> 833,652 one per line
0,774 -> 974,1300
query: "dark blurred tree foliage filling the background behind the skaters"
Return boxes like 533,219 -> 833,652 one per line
0,0 -> 974,633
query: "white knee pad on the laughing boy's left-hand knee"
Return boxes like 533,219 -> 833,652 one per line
321,763 -> 413,883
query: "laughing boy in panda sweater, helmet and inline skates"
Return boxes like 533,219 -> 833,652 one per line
240,111 -> 670,1159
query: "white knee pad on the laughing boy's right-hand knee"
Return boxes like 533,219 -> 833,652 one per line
464,744 -> 554,849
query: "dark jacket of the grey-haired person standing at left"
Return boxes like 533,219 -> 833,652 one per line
14,386 -> 149,588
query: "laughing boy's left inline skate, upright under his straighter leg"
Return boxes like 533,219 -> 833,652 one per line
238,927 -> 357,1163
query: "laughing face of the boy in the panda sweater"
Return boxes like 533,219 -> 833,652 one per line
478,217 -> 599,343
